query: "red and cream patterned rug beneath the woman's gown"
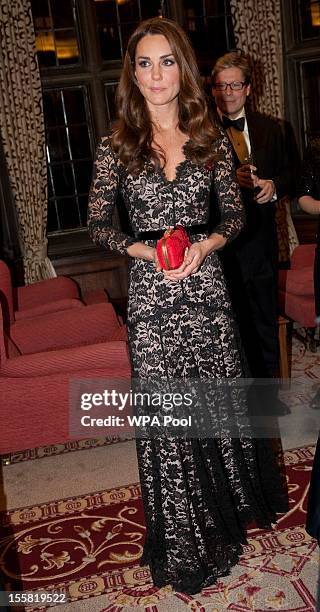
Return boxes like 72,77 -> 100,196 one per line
0,446 -> 319,612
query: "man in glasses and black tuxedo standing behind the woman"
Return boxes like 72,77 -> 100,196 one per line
212,52 -> 294,378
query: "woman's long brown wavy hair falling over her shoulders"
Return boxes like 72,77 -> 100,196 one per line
112,17 -> 219,174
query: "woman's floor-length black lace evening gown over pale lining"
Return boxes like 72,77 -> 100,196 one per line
89,137 -> 286,593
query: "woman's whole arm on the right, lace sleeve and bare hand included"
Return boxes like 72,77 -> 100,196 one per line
164,136 -> 244,280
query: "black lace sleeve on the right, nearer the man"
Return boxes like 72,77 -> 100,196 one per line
213,135 -> 245,242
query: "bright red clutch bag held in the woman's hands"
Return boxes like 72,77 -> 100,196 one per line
156,225 -> 191,270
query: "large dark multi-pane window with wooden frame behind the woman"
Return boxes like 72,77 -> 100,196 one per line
31,0 -> 234,244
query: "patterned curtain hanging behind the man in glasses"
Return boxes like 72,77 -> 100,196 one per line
230,0 -> 299,261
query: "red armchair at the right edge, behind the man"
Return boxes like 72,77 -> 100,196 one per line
278,244 -> 316,350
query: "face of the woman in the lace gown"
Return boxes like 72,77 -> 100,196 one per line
135,34 -> 180,110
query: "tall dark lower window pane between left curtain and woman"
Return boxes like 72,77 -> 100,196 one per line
43,86 -> 94,231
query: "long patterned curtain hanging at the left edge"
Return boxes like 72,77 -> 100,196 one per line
0,0 -> 55,283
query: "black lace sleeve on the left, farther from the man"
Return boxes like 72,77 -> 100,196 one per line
88,138 -> 135,255
